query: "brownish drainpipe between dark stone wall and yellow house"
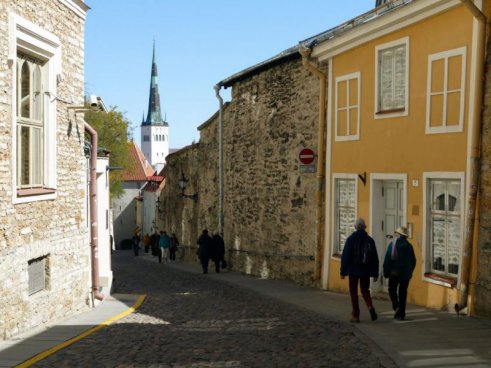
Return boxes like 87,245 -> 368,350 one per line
299,46 -> 327,282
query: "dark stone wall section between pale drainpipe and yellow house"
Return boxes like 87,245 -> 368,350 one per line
224,58 -> 319,284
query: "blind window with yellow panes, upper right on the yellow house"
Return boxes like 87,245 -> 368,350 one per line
426,47 -> 466,134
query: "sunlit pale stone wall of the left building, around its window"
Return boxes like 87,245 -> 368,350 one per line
0,0 -> 90,339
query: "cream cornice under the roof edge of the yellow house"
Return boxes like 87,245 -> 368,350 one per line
312,0 -> 462,61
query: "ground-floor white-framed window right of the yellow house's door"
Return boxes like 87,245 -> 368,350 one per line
427,178 -> 463,277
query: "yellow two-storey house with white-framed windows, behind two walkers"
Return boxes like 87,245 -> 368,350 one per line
310,0 -> 489,308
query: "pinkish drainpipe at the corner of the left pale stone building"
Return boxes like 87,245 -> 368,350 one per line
84,122 -> 104,300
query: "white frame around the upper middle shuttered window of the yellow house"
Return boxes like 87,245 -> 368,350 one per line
374,37 -> 409,119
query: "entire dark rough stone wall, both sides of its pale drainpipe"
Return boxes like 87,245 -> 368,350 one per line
161,57 -> 319,285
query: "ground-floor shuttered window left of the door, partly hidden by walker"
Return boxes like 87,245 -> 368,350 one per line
333,177 -> 356,254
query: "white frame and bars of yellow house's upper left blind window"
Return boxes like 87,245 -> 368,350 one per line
335,72 -> 361,142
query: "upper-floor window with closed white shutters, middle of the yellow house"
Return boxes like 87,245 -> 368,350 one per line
375,37 -> 409,116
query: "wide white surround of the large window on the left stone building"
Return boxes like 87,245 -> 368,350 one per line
8,13 -> 62,204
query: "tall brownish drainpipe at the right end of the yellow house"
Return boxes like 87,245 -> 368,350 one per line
455,0 -> 486,314
